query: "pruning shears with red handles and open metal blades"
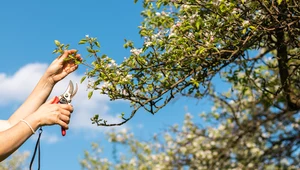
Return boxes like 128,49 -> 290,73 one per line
51,80 -> 78,136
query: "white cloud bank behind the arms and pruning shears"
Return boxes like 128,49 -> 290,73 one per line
0,63 -> 125,143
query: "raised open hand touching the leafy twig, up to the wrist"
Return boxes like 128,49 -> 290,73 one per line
45,49 -> 82,84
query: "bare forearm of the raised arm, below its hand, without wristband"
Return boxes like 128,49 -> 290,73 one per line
8,75 -> 55,126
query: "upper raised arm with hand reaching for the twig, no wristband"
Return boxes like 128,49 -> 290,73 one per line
6,50 -> 81,127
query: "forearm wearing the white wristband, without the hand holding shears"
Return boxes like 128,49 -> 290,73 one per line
0,116 -> 39,162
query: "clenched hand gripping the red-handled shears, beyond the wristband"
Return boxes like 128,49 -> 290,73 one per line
33,98 -> 73,129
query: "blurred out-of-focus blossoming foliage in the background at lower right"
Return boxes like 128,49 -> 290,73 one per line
81,53 -> 300,170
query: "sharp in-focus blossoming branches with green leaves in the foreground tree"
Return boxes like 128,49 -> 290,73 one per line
54,0 -> 300,126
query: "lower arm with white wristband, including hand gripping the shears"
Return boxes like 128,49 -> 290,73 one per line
0,99 -> 73,162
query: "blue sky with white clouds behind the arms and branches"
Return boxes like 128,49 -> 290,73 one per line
0,0 -> 213,170
